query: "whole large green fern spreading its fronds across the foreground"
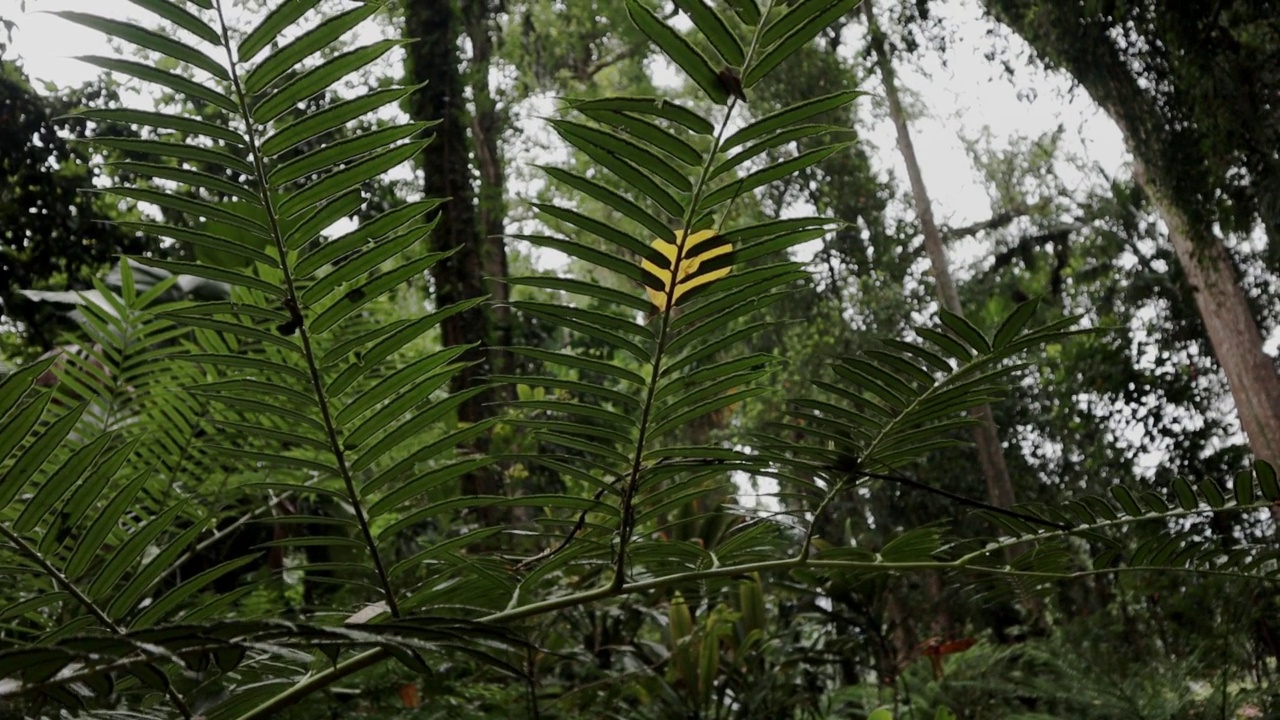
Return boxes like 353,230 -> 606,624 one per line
0,0 -> 1280,720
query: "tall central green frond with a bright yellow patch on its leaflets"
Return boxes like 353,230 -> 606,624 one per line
494,0 -> 859,593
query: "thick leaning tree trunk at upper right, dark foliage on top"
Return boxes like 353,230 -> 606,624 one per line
983,0 -> 1280,464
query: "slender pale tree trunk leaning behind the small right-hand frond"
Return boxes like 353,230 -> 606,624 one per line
863,0 -> 1016,507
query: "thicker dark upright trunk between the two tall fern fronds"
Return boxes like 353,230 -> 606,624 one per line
404,0 -> 503,512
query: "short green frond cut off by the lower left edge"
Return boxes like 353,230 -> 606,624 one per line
0,359 -> 202,717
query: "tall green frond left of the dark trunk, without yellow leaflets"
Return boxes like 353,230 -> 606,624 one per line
53,3 -> 488,615
